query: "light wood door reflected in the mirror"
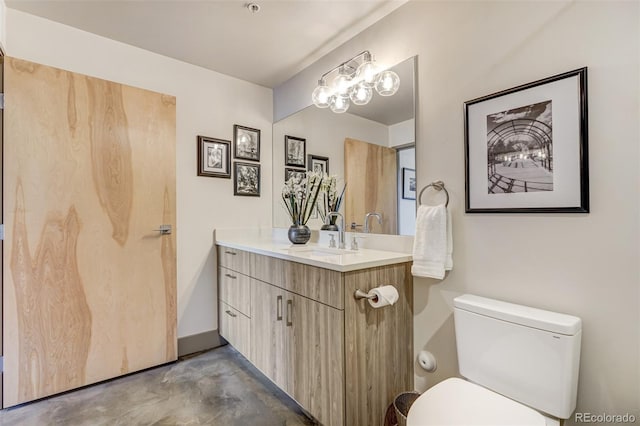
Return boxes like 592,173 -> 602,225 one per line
344,138 -> 398,234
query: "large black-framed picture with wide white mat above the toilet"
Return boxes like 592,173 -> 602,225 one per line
464,68 -> 589,213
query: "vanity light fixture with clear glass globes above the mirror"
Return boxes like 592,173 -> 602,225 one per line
311,50 -> 400,114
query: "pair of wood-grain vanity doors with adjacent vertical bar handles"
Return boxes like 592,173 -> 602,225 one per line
250,280 -> 344,425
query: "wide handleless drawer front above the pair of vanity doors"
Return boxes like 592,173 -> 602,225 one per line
253,254 -> 344,309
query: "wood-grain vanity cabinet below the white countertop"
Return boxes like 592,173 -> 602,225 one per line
217,242 -> 413,426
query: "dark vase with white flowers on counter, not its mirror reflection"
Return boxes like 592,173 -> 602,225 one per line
282,171 -> 323,244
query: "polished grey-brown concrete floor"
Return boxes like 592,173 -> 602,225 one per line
0,345 -> 316,426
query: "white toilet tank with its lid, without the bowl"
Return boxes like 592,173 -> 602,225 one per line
453,294 -> 582,419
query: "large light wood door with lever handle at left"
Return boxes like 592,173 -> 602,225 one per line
3,58 -> 177,407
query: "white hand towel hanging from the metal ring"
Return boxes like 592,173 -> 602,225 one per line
411,205 -> 453,280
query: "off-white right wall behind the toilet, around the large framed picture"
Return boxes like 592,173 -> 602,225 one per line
274,1 -> 640,424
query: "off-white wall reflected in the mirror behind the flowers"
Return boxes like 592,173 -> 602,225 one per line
273,106 -> 389,229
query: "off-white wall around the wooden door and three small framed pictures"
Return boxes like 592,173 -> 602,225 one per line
6,9 -> 273,337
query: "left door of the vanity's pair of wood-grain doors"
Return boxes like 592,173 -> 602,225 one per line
250,279 -> 289,392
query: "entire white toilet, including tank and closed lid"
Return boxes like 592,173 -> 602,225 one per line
407,294 -> 582,426
